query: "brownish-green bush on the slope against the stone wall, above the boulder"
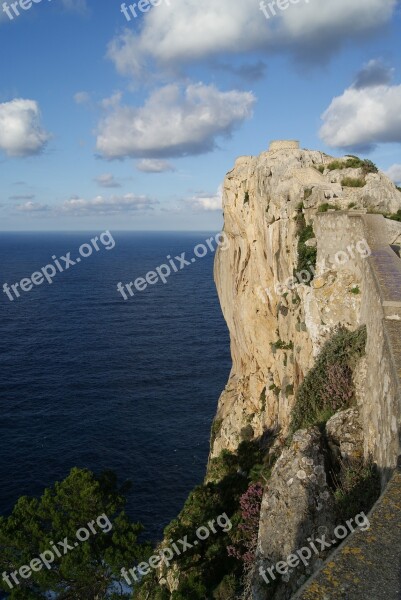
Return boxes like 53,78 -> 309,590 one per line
291,327 -> 366,432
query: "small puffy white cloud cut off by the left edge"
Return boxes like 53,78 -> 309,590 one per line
0,98 -> 50,156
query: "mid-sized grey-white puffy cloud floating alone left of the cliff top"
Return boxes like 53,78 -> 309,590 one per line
97,83 -> 255,158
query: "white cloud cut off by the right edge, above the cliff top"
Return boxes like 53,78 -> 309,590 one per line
320,85 -> 401,150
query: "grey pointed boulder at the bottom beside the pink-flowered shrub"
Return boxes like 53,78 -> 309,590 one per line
252,428 -> 334,600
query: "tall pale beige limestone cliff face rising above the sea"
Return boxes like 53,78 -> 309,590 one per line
211,142 -> 401,458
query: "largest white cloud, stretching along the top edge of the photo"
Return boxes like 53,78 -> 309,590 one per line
108,0 -> 397,76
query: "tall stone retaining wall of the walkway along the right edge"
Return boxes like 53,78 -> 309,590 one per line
314,212 -> 401,486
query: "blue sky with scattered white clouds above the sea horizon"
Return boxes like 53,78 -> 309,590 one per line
0,0 -> 401,231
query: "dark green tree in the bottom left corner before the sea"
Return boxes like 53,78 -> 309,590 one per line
0,468 -> 147,600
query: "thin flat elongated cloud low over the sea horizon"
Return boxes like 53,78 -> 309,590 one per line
61,194 -> 158,216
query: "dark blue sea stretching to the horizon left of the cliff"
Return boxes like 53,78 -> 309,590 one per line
0,231 -> 231,540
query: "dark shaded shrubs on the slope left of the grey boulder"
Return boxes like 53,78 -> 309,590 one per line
134,436 -> 275,600
